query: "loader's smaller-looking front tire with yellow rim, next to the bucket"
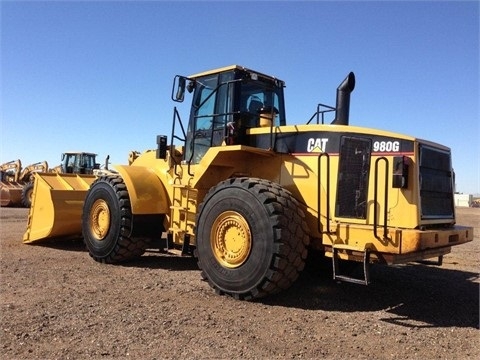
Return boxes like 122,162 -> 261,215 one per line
82,176 -> 148,263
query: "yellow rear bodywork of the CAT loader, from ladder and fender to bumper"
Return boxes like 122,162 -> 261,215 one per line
142,138 -> 473,259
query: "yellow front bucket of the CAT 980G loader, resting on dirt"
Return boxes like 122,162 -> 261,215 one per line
23,173 -> 96,243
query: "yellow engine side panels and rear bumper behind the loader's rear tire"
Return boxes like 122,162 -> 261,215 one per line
274,150 -> 473,263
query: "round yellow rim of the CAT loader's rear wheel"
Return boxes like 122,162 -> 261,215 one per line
210,211 -> 252,268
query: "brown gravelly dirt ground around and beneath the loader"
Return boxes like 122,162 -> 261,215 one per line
0,208 -> 480,359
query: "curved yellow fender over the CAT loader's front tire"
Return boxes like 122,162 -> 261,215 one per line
115,165 -> 169,215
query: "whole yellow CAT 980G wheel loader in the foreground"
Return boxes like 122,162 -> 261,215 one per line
24,66 -> 473,299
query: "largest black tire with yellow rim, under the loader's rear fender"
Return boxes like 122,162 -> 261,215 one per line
196,178 -> 309,300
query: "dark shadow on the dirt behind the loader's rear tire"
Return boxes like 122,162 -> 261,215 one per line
268,259 -> 479,329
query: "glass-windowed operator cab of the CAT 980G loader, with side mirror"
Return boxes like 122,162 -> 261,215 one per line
172,65 -> 286,164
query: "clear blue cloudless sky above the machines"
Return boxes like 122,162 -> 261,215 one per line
0,0 -> 480,194
